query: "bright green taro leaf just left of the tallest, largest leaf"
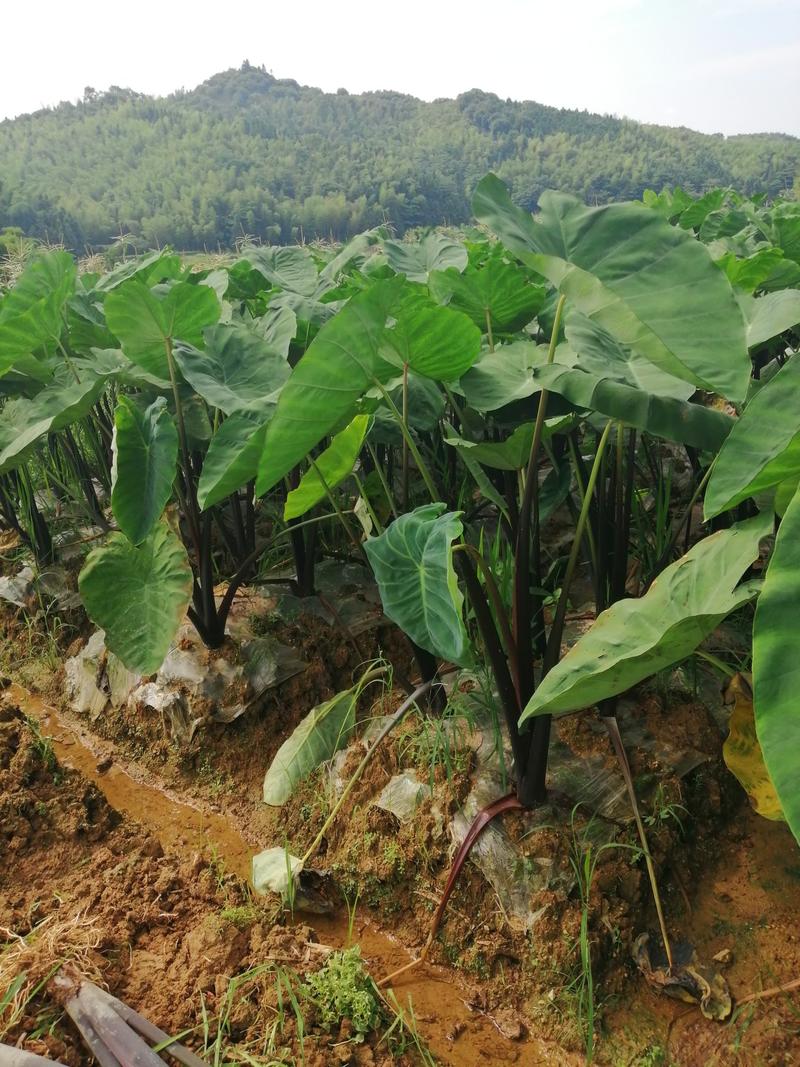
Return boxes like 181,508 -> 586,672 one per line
428,256 -> 547,333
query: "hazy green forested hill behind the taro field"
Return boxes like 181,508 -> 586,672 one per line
0,63 -> 800,251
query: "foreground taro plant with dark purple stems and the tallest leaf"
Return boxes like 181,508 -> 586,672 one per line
251,176 -> 765,973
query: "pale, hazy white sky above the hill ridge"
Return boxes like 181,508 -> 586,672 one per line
0,0 -> 800,136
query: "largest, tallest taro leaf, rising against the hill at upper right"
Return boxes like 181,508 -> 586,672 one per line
473,175 -> 750,401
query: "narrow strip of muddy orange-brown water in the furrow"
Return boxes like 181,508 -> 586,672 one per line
9,685 -> 580,1067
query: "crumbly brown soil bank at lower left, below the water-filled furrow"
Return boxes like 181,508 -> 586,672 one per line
0,700 -> 419,1067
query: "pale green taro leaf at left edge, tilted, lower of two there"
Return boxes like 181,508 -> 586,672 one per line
0,373 -> 107,474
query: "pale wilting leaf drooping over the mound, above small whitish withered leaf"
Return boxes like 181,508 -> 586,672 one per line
263,688 -> 356,808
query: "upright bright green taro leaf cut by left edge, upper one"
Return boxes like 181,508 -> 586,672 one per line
0,252 -> 76,375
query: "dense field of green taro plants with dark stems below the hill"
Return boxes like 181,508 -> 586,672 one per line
0,175 -> 800,943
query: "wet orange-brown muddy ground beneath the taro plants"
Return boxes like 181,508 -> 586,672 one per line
0,593 -> 800,1067
